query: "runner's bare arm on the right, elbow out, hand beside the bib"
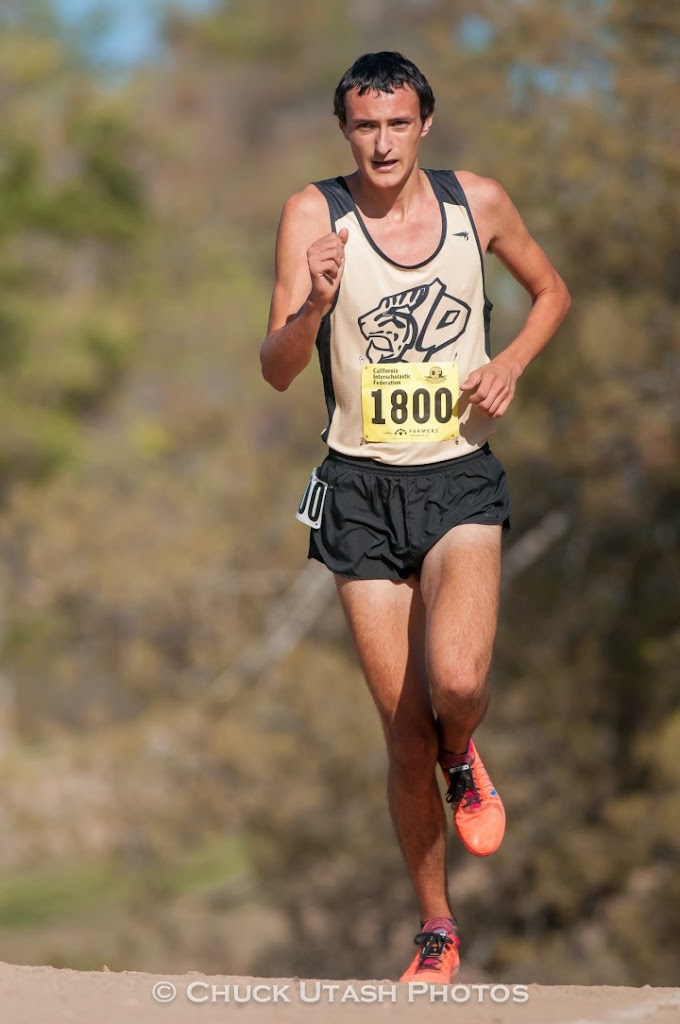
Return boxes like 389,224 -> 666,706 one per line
459,172 -> 570,419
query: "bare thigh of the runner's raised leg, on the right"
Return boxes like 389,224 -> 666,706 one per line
420,523 -> 501,674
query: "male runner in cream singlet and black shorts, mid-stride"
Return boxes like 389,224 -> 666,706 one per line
261,52 -> 569,983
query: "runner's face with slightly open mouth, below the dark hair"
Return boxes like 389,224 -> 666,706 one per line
340,86 -> 432,188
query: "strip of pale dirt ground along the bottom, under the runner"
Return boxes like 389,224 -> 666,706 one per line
0,964 -> 680,1024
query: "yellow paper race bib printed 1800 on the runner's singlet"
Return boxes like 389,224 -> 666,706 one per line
362,362 -> 458,441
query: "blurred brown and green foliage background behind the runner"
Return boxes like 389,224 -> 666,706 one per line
0,0 -> 680,985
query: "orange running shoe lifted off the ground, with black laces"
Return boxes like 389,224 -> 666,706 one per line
439,740 -> 505,857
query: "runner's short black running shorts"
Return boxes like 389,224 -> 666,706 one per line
303,444 -> 510,580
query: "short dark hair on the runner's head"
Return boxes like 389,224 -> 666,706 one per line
333,50 -> 434,124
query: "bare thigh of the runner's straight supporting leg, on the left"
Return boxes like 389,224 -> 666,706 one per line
336,577 -> 433,731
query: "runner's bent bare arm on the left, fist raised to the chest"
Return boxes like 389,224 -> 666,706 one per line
260,185 -> 347,391
